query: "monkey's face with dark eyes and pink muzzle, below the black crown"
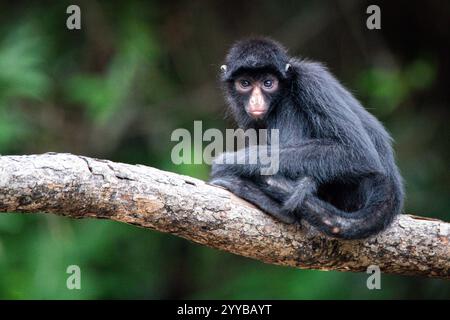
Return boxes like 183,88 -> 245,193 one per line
233,73 -> 280,120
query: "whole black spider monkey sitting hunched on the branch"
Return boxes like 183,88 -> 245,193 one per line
211,38 -> 404,239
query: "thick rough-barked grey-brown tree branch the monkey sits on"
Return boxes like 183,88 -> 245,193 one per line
0,153 -> 450,279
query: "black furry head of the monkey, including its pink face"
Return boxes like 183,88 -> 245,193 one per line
221,38 -> 290,126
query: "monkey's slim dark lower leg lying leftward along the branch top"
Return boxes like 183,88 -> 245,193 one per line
209,176 -> 296,223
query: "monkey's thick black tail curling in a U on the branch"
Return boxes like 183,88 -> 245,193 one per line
300,176 -> 403,239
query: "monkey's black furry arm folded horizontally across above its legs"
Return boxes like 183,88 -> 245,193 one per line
215,139 -> 383,183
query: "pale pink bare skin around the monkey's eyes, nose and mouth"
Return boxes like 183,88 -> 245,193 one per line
234,74 -> 279,119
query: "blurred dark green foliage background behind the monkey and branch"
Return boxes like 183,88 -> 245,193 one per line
0,0 -> 450,299
